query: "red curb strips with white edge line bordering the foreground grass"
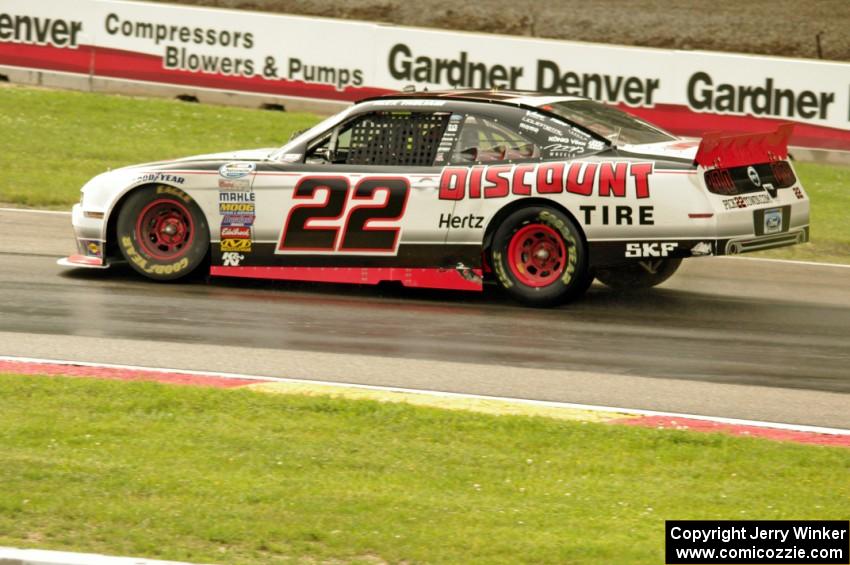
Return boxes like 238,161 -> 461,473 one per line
0,356 -> 850,447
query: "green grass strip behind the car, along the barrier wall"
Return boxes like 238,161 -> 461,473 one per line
0,86 -> 850,263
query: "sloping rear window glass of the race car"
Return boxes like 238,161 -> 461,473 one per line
541,100 -> 677,145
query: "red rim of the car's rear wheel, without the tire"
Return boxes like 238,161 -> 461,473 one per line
508,224 -> 567,288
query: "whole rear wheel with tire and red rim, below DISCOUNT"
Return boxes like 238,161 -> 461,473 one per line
491,206 -> 593,307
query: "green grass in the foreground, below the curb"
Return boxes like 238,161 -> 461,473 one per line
0,374 -> 850,563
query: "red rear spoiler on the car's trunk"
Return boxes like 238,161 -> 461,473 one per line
694,124 -> 794,168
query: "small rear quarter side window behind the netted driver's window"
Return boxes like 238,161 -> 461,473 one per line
451,115 -> 540,163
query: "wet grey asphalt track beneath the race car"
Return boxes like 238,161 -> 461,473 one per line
0,211 -> 850,427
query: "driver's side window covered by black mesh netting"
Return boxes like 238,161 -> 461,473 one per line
306,112 -> 449,167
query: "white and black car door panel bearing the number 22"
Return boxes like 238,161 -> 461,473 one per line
243,165 -> 454,267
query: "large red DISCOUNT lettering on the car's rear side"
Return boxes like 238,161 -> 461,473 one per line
440,161 -> 653,200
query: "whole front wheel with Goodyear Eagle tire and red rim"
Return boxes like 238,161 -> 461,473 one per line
116,185 -> 210,281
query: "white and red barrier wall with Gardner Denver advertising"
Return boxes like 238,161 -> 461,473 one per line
0,0 -> 850,151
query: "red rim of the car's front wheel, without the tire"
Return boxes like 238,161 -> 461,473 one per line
136,198 -> 195,261
